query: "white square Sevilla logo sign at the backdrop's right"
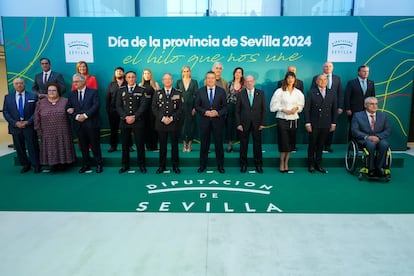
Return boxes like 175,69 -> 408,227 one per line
328,33 -> 358,62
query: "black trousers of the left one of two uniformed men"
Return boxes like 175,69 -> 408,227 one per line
121,127 -> 145,168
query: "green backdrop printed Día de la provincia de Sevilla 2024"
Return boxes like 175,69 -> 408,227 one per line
2,17 -> 414,150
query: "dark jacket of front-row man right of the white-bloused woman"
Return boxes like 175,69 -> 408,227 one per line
303,87 -> 338,128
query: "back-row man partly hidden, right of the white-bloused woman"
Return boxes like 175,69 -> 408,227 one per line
311,62 -> 344,152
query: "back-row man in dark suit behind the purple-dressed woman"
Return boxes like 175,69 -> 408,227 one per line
32,58 -> 66,98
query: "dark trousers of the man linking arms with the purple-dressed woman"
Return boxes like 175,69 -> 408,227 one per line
78,126 -> 102,166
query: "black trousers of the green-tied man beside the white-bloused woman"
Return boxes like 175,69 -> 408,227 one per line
239,123 -> 263,166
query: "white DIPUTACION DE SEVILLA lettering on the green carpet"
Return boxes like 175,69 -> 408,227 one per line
136,179 -> 283,213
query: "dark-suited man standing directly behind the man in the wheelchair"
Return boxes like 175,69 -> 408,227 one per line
345,65 -> 375,139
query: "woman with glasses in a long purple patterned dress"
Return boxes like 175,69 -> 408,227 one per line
34,83 -> 75,172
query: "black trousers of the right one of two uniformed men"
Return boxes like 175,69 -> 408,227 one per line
158,130 -> 180,168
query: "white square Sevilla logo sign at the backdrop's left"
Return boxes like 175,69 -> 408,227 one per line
64,34 -> 93,62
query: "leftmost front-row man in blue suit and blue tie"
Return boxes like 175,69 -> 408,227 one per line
3,78 -> 40,173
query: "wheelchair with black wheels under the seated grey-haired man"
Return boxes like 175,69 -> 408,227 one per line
345,139 -> 392,182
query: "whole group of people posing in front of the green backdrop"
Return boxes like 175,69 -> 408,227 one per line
3,58 -> 390,177
